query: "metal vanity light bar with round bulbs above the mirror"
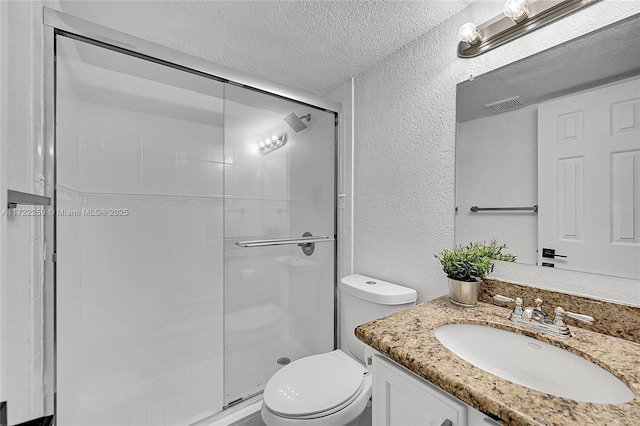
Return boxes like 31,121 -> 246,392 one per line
458,0 -> 600,58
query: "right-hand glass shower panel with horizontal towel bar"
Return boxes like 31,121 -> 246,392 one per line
224,85 -> 336,405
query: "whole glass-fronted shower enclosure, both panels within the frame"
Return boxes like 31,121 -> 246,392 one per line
54,33 -> 336,426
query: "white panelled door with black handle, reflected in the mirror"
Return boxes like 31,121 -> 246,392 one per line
538,78 -> 640,278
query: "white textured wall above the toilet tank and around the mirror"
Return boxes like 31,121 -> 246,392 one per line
354,0 -> 640,302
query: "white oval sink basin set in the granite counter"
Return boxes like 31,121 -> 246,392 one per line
435,324 -> 633,404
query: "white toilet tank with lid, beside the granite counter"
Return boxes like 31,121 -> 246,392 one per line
340,274 -> 417,363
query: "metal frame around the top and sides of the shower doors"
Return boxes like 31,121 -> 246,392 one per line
42,7 -> 340,418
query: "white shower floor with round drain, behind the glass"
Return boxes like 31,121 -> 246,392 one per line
58,337 -> 311,426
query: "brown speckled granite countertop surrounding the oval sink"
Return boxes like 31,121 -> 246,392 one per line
355,296 -> 640,426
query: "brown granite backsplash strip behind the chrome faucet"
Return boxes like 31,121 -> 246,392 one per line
478,278 -> 640,343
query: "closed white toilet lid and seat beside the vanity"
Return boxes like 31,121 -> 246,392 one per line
263,350 -> 369,420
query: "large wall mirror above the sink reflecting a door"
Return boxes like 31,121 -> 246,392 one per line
455,15 -> 640,279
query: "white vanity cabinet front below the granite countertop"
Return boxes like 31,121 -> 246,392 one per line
367,350 -> 501,426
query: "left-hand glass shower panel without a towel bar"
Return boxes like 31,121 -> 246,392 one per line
55,36 -> 224,426
